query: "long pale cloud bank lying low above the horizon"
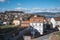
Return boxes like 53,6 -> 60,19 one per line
2,7 -> 60,13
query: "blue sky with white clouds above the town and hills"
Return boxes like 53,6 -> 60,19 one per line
0,0 -> 60,12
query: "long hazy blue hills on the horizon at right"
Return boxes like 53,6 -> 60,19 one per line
33,12 -> 60,17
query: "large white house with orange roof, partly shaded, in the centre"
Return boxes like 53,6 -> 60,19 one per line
30,15 -> 45,35
